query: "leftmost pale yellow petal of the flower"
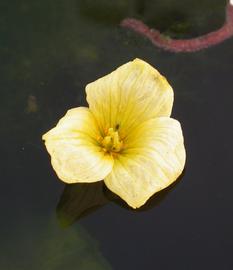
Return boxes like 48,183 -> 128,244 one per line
43,107 -> 113,183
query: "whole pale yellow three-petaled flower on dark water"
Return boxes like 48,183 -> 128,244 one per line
43,59 -> 185,208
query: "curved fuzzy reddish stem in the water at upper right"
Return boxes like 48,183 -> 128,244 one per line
121,3 -> 233,52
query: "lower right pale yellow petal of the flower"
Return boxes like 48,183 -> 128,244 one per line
104,117 -> 185,208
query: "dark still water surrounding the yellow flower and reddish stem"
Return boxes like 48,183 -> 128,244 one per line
0,0 -> 233,270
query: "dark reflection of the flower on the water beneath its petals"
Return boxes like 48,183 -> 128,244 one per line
56,170 -> 185,227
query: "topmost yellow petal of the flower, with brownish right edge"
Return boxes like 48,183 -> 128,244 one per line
86,59 -> 173,133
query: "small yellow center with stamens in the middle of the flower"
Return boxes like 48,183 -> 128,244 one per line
101,128 -> 123,152
